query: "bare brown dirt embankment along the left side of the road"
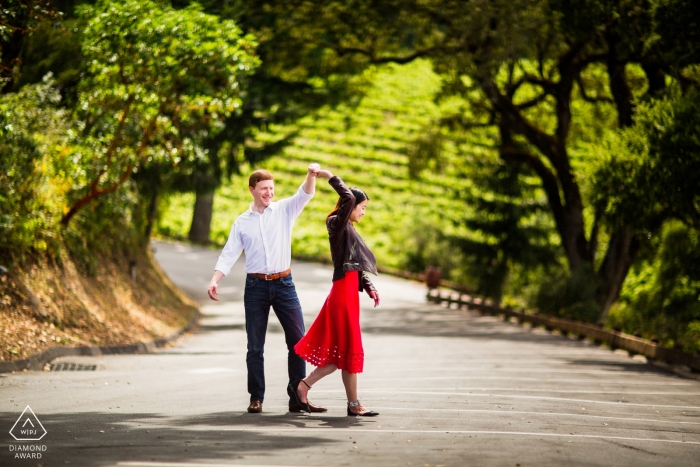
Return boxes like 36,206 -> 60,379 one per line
0,250 -> 197,361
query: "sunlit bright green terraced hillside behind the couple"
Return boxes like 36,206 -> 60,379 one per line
158,61 -> 542,288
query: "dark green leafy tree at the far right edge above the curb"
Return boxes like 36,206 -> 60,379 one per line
594,88 -> 700,338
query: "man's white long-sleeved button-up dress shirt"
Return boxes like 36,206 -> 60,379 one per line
214,185 -> 314,276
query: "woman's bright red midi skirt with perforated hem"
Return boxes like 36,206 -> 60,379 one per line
294,271 -> 365,373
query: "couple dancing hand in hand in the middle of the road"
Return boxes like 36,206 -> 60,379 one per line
208,164 -> 379,417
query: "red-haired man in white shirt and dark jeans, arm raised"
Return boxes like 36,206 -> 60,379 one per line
208,164 -> 327,413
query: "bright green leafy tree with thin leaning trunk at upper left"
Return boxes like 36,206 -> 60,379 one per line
61,0 -> 258,225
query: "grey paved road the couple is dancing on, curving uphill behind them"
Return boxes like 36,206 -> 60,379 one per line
0,244 -> 700,467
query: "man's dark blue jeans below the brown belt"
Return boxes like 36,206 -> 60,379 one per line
243,274 -> 306,402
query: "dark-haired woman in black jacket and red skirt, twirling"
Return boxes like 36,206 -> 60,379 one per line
290,170 -> 379,417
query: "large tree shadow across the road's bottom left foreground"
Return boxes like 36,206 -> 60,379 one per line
0,412 -> 367,467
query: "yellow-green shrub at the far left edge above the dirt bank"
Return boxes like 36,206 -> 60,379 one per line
0,77 -> 70,261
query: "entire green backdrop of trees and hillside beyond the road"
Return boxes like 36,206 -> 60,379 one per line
0,0 -> 700,358
